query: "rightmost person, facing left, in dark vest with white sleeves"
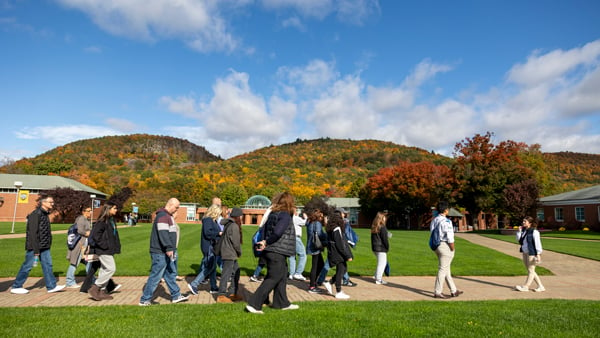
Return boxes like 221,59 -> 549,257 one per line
515,216 -> 546,292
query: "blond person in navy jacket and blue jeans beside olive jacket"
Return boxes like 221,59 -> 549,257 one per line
188,204 -> 223,295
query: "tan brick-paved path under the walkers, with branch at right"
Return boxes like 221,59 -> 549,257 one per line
0,233 -> 600,307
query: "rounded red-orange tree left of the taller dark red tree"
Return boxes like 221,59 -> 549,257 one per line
358,162 -> 455,224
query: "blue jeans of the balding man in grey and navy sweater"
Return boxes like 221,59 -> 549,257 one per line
140,251 -> 181,303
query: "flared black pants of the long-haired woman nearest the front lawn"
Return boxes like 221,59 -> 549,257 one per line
248,251 -> 290,310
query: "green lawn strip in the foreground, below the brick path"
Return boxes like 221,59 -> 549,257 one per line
0,299 -> 600,337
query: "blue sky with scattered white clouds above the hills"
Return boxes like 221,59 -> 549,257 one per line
0,0 -> 600,160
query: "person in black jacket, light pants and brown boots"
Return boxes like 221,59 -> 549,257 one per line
88,201 -> 121,300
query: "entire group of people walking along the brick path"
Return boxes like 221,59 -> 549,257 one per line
11,192 -> 545,306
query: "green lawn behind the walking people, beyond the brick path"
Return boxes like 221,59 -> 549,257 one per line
0,224 -> 551,277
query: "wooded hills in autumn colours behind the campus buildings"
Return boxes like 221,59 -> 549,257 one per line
0,134 -> 600,211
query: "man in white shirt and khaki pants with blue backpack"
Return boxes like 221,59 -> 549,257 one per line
429,201 -> 463,299
